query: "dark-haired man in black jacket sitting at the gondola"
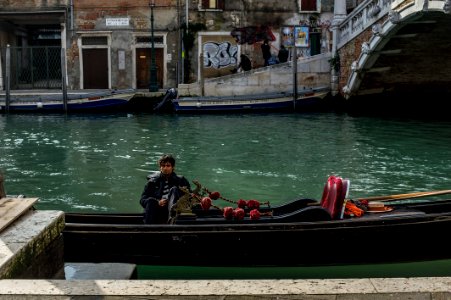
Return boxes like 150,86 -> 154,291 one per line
139,155 -> 191,224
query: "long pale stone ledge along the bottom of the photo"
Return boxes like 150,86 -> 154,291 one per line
0,277 -> 451,300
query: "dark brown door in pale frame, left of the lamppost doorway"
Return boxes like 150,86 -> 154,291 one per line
83,49 -> 108,89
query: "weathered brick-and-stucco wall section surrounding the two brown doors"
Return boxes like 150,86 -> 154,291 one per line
67,0 -> 180,89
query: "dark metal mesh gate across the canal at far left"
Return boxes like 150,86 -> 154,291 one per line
0,46 -> 62,90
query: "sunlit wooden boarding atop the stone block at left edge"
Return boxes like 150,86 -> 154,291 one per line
0,198 -> 38,232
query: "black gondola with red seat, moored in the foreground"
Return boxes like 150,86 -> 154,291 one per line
63,176 -> 451,266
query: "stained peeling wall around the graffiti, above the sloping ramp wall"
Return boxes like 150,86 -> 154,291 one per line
189,0 -> 333,82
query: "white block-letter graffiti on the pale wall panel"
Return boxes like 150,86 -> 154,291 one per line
203,42 -> 238,69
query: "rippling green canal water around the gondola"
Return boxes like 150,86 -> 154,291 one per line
0,112 -> 451,278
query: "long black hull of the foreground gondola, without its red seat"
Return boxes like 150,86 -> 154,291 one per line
63,201 -> 451,266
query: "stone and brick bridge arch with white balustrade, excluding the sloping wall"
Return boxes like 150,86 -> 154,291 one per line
332,0 -> 451,99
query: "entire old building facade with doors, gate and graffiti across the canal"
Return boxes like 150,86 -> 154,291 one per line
0,0 -> 340,89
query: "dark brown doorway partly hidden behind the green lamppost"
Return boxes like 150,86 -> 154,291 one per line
136,48 -> 163,89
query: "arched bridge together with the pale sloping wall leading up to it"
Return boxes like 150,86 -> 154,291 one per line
178,0 -> 451,111
